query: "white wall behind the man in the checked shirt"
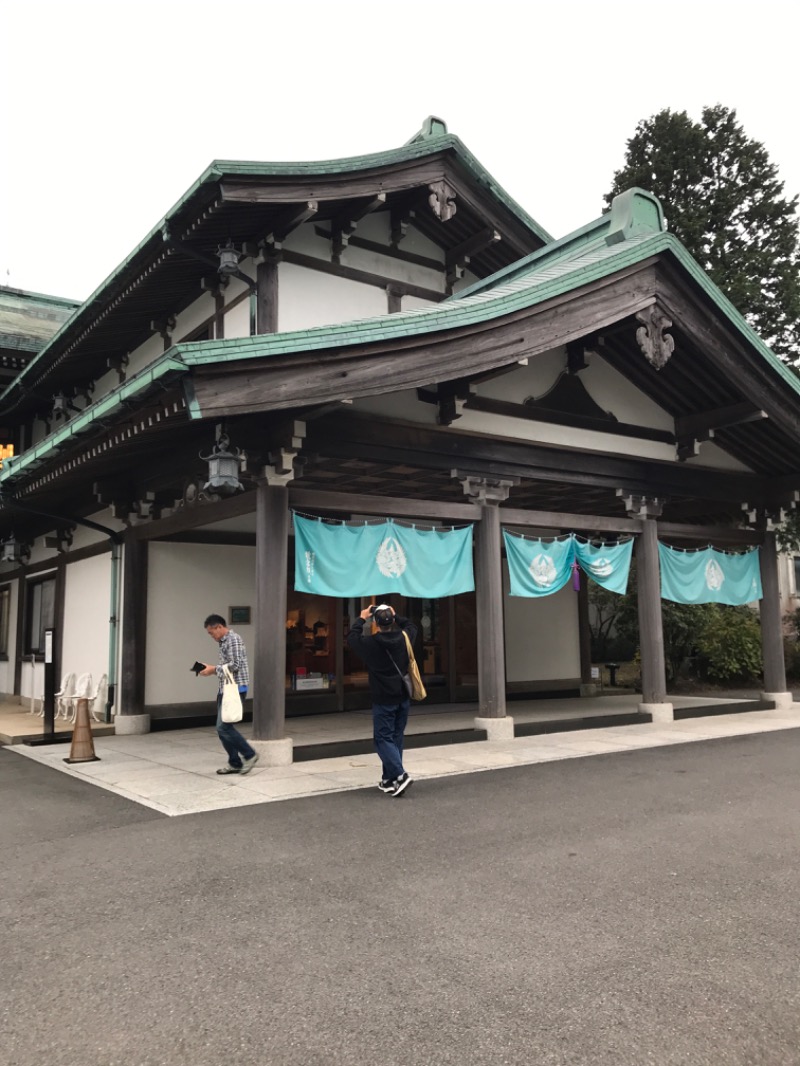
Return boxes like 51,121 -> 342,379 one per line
145,543 -> 256,713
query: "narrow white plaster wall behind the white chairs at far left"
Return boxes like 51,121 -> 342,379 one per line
62,551 -> 111,684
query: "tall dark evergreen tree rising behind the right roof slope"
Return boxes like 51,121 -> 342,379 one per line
605,104 -> 800,364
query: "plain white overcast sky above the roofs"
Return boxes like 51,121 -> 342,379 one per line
0,0 -> 800,300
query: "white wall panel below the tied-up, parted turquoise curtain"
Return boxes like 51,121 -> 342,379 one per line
502,560 -> 580,682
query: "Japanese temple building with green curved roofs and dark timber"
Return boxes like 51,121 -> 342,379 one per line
0,118 -> 800,762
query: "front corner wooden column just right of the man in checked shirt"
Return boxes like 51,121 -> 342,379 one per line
253,477 -> 289,741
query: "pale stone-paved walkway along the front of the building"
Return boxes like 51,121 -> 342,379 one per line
6,696 -> 800,815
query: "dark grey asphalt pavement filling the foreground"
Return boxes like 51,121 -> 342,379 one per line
0,729 -> 800,1066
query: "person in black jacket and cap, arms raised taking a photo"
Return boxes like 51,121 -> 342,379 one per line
348,603 -> 417,796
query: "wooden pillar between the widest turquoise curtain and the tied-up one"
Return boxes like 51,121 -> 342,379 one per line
475,502 -> 506,718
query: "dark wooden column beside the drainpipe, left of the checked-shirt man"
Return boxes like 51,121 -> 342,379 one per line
116,529 -> 147,715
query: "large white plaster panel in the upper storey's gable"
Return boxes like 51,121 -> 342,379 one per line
277,262 -> 388,336
